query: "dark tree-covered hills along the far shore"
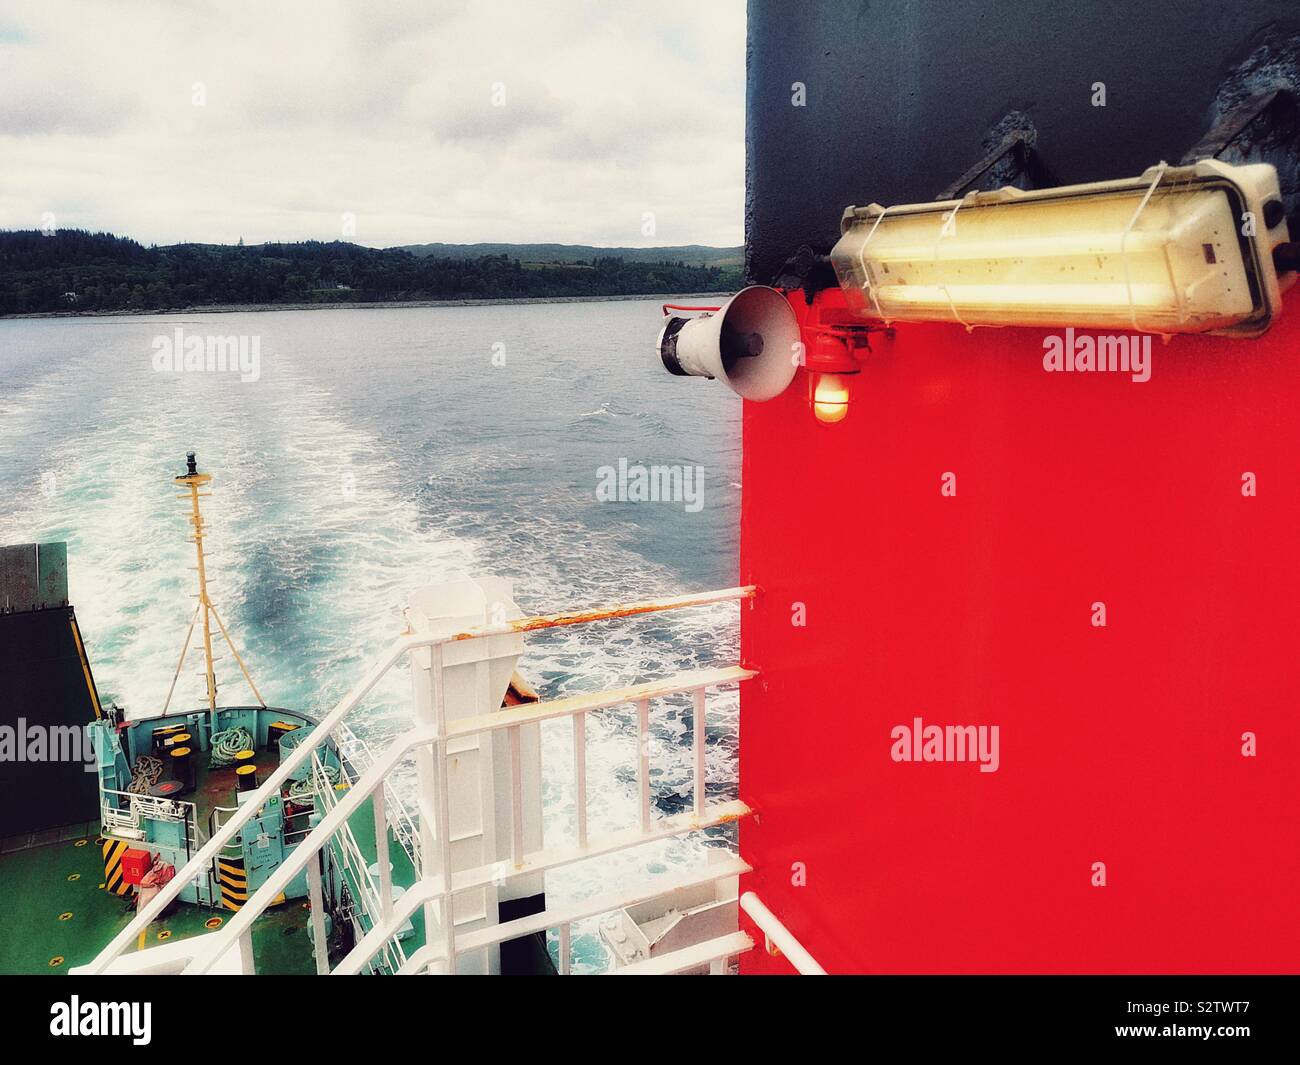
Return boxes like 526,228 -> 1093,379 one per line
0,229 -> 741,315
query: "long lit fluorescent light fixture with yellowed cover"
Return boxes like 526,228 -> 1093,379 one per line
831,160 -> 1294,335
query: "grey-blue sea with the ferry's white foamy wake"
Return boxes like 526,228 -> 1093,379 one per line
0,302 -> 738,971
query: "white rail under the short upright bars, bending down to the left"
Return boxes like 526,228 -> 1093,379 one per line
334,800 -> 750,975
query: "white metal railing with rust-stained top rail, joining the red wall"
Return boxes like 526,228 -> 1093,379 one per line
82,585 -> 755,974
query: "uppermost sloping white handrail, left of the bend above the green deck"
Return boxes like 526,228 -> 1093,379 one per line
85,637 -> 408,975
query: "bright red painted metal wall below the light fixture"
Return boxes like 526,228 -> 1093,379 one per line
741,291 -> 1300,973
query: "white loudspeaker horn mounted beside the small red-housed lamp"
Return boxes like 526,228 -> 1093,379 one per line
657,285 -> 800,401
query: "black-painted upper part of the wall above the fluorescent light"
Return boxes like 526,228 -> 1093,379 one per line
745,0 -> 1300,283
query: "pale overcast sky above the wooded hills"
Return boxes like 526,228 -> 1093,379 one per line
0,0 -> 745,247
